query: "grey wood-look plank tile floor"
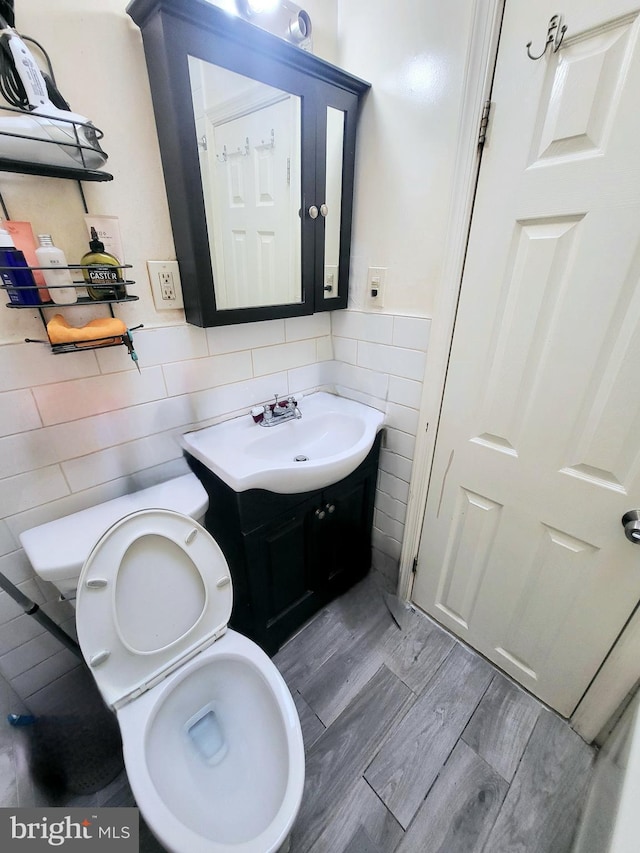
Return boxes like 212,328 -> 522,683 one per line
0,574 -> 594,853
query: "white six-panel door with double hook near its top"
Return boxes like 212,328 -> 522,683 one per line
413,0 -> 640,716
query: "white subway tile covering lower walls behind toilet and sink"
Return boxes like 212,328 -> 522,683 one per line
0,310 -> 430,703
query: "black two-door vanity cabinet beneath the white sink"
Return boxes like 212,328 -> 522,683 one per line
187,433 -> 381,655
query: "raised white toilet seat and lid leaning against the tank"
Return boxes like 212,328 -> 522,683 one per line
76,509 -> 233,709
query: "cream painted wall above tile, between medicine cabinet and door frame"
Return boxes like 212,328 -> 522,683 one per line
338,0 -> 475,317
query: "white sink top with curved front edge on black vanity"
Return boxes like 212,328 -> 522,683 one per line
181,391 -> 384,494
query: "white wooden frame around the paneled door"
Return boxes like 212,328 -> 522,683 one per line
397,0 -> 640,743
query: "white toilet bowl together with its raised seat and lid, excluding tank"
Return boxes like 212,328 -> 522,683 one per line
76,509 -> 304,853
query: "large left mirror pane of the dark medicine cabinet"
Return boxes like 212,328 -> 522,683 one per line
189,57 -> 302,310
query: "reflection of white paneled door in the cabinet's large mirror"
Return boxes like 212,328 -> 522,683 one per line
209,97 -> 301,309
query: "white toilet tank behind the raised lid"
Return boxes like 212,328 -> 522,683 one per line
20,473 -> 209,598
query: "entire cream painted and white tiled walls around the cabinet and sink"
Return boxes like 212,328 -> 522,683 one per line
0,0 -> 480,699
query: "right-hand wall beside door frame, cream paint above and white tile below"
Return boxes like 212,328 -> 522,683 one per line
332,0 -> 476,576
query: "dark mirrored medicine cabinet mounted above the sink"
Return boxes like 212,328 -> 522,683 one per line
127,0 -> 369,326
